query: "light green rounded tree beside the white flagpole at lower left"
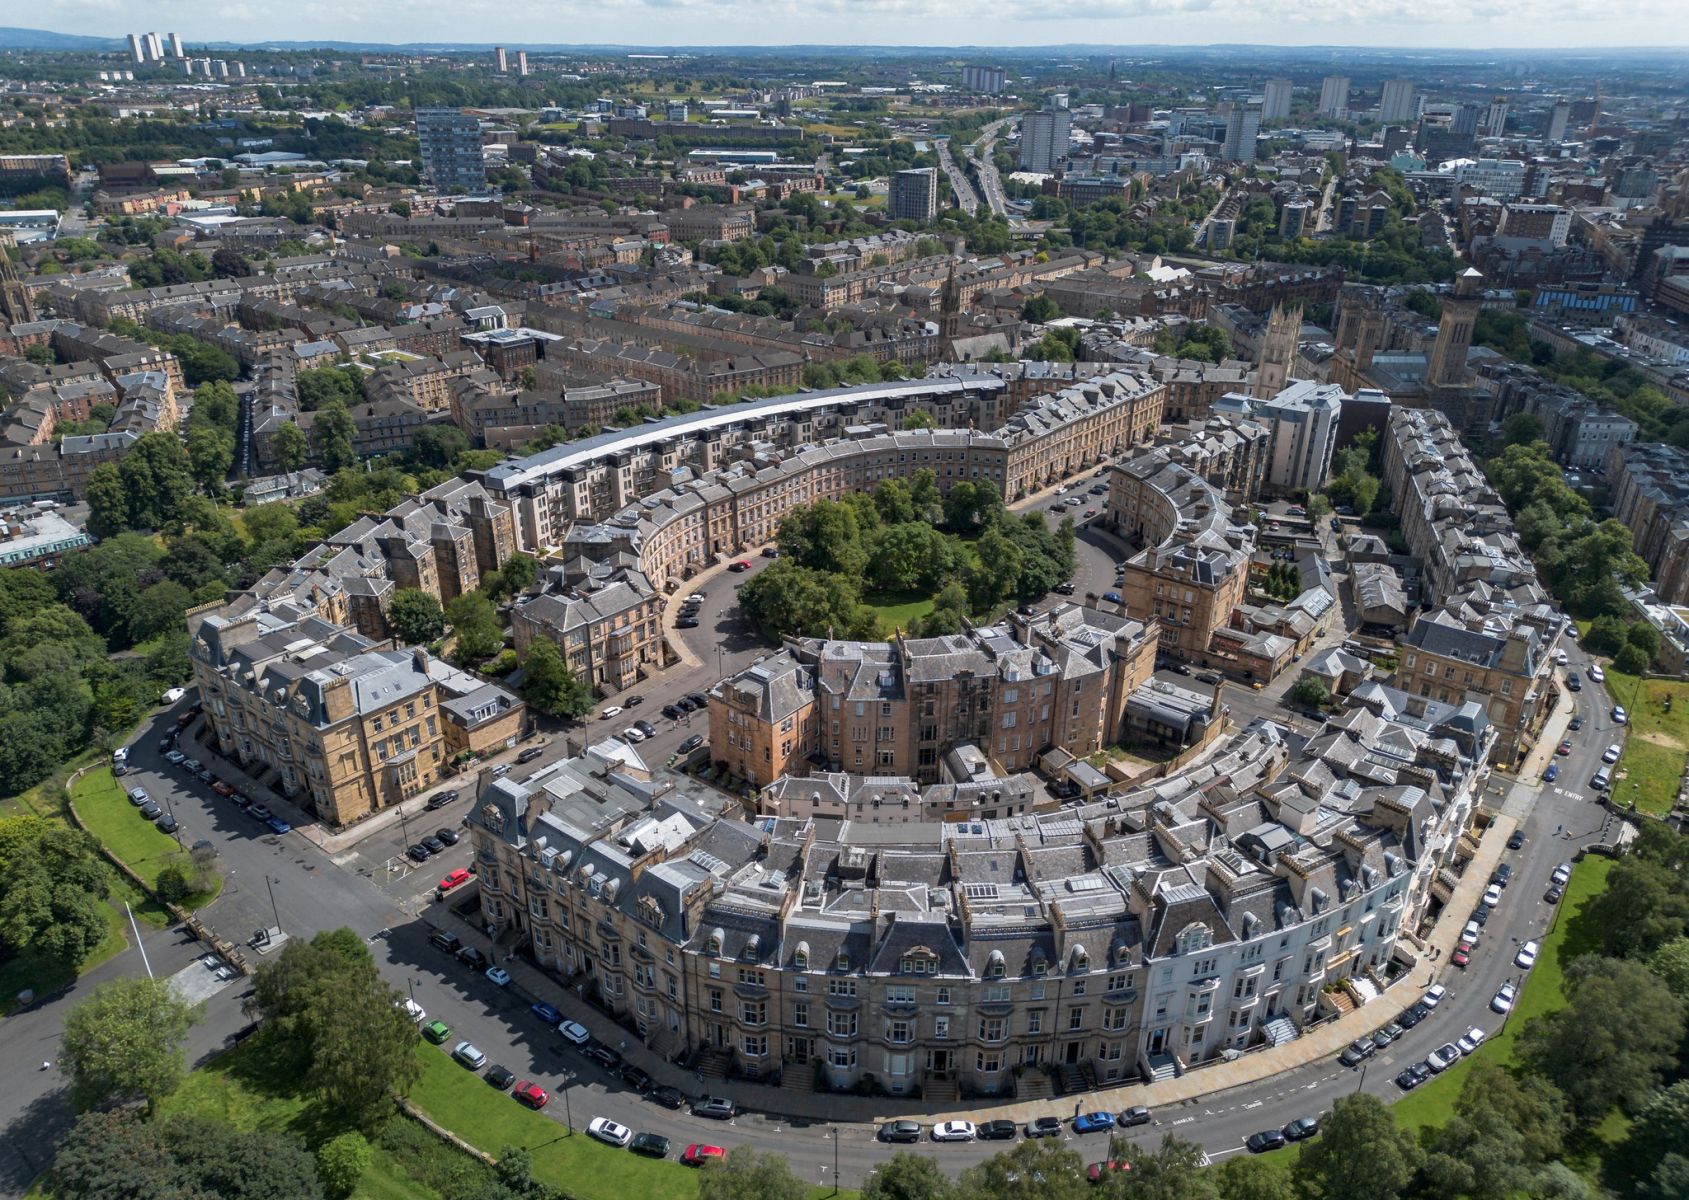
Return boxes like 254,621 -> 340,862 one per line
61,977 -> 193,1112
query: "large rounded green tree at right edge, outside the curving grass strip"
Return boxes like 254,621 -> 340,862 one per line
1515,953 -> 1684,1122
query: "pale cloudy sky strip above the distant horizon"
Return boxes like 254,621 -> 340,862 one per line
37,0 -> 1689,49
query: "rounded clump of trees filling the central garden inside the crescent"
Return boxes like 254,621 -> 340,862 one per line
740,470 -> 1074,649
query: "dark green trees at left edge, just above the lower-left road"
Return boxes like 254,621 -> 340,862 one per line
0,813 -> 111,970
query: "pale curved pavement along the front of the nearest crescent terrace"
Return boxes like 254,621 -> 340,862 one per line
422,815 -> 1517,1124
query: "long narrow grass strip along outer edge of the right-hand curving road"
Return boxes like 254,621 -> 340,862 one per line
1390,855 -> 1613,1131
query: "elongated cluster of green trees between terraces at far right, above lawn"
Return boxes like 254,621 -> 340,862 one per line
1485,441 -> 1648,617
